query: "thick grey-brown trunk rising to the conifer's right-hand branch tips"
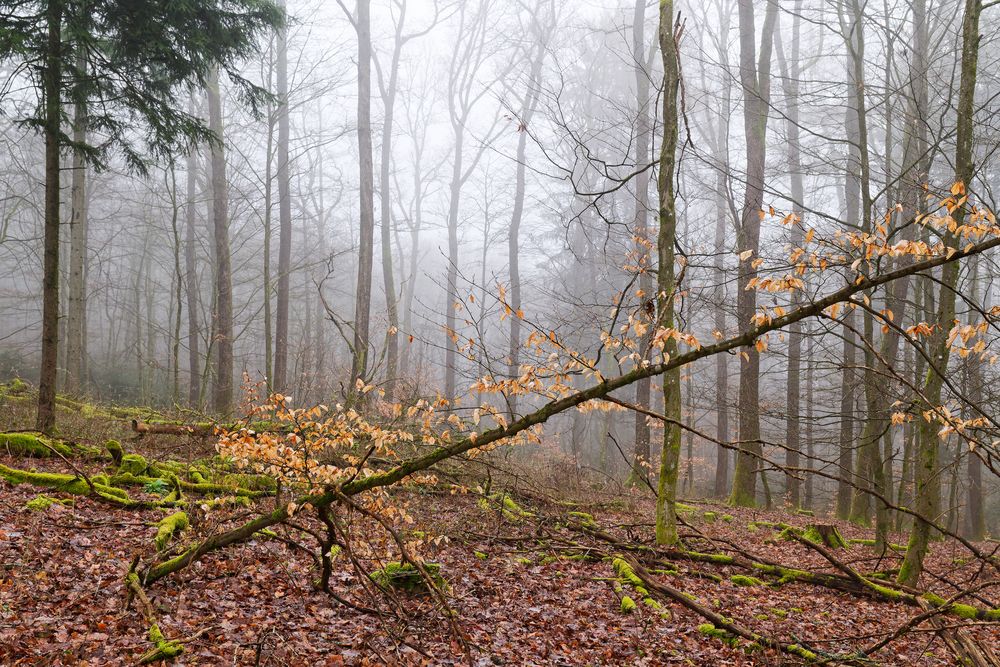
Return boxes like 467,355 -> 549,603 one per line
207,70 -> 233,415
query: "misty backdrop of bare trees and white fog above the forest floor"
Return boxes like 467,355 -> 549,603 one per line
0,0 -> 1000,552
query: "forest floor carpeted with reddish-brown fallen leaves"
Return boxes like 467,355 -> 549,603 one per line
0,406 -> 1000,665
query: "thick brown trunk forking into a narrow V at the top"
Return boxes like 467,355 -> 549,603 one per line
729,0 -> 778,507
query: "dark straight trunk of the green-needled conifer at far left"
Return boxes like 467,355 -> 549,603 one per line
35,0 -> 63,433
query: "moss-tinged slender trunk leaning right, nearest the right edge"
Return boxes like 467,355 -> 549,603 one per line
898,0 -> 982,586
